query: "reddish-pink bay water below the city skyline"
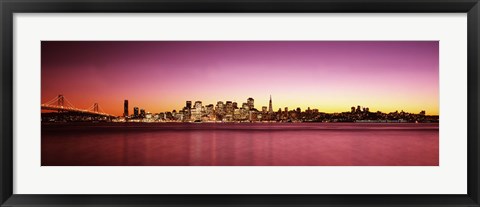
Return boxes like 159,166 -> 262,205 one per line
41,123 -> 439,166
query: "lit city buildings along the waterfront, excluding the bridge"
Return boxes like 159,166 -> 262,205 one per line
117,96 -> 439,123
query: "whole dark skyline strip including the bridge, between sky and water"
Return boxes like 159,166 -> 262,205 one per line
42,95 -> 439,123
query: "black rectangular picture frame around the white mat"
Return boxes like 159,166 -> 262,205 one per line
0,0 -> 480,207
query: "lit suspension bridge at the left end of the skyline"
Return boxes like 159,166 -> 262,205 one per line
41,94 -> 117,118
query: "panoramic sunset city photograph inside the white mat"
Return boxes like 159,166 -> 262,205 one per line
40,41 -> 440,166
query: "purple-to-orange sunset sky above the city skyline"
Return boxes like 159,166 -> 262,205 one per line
41,41 -> 439,115
